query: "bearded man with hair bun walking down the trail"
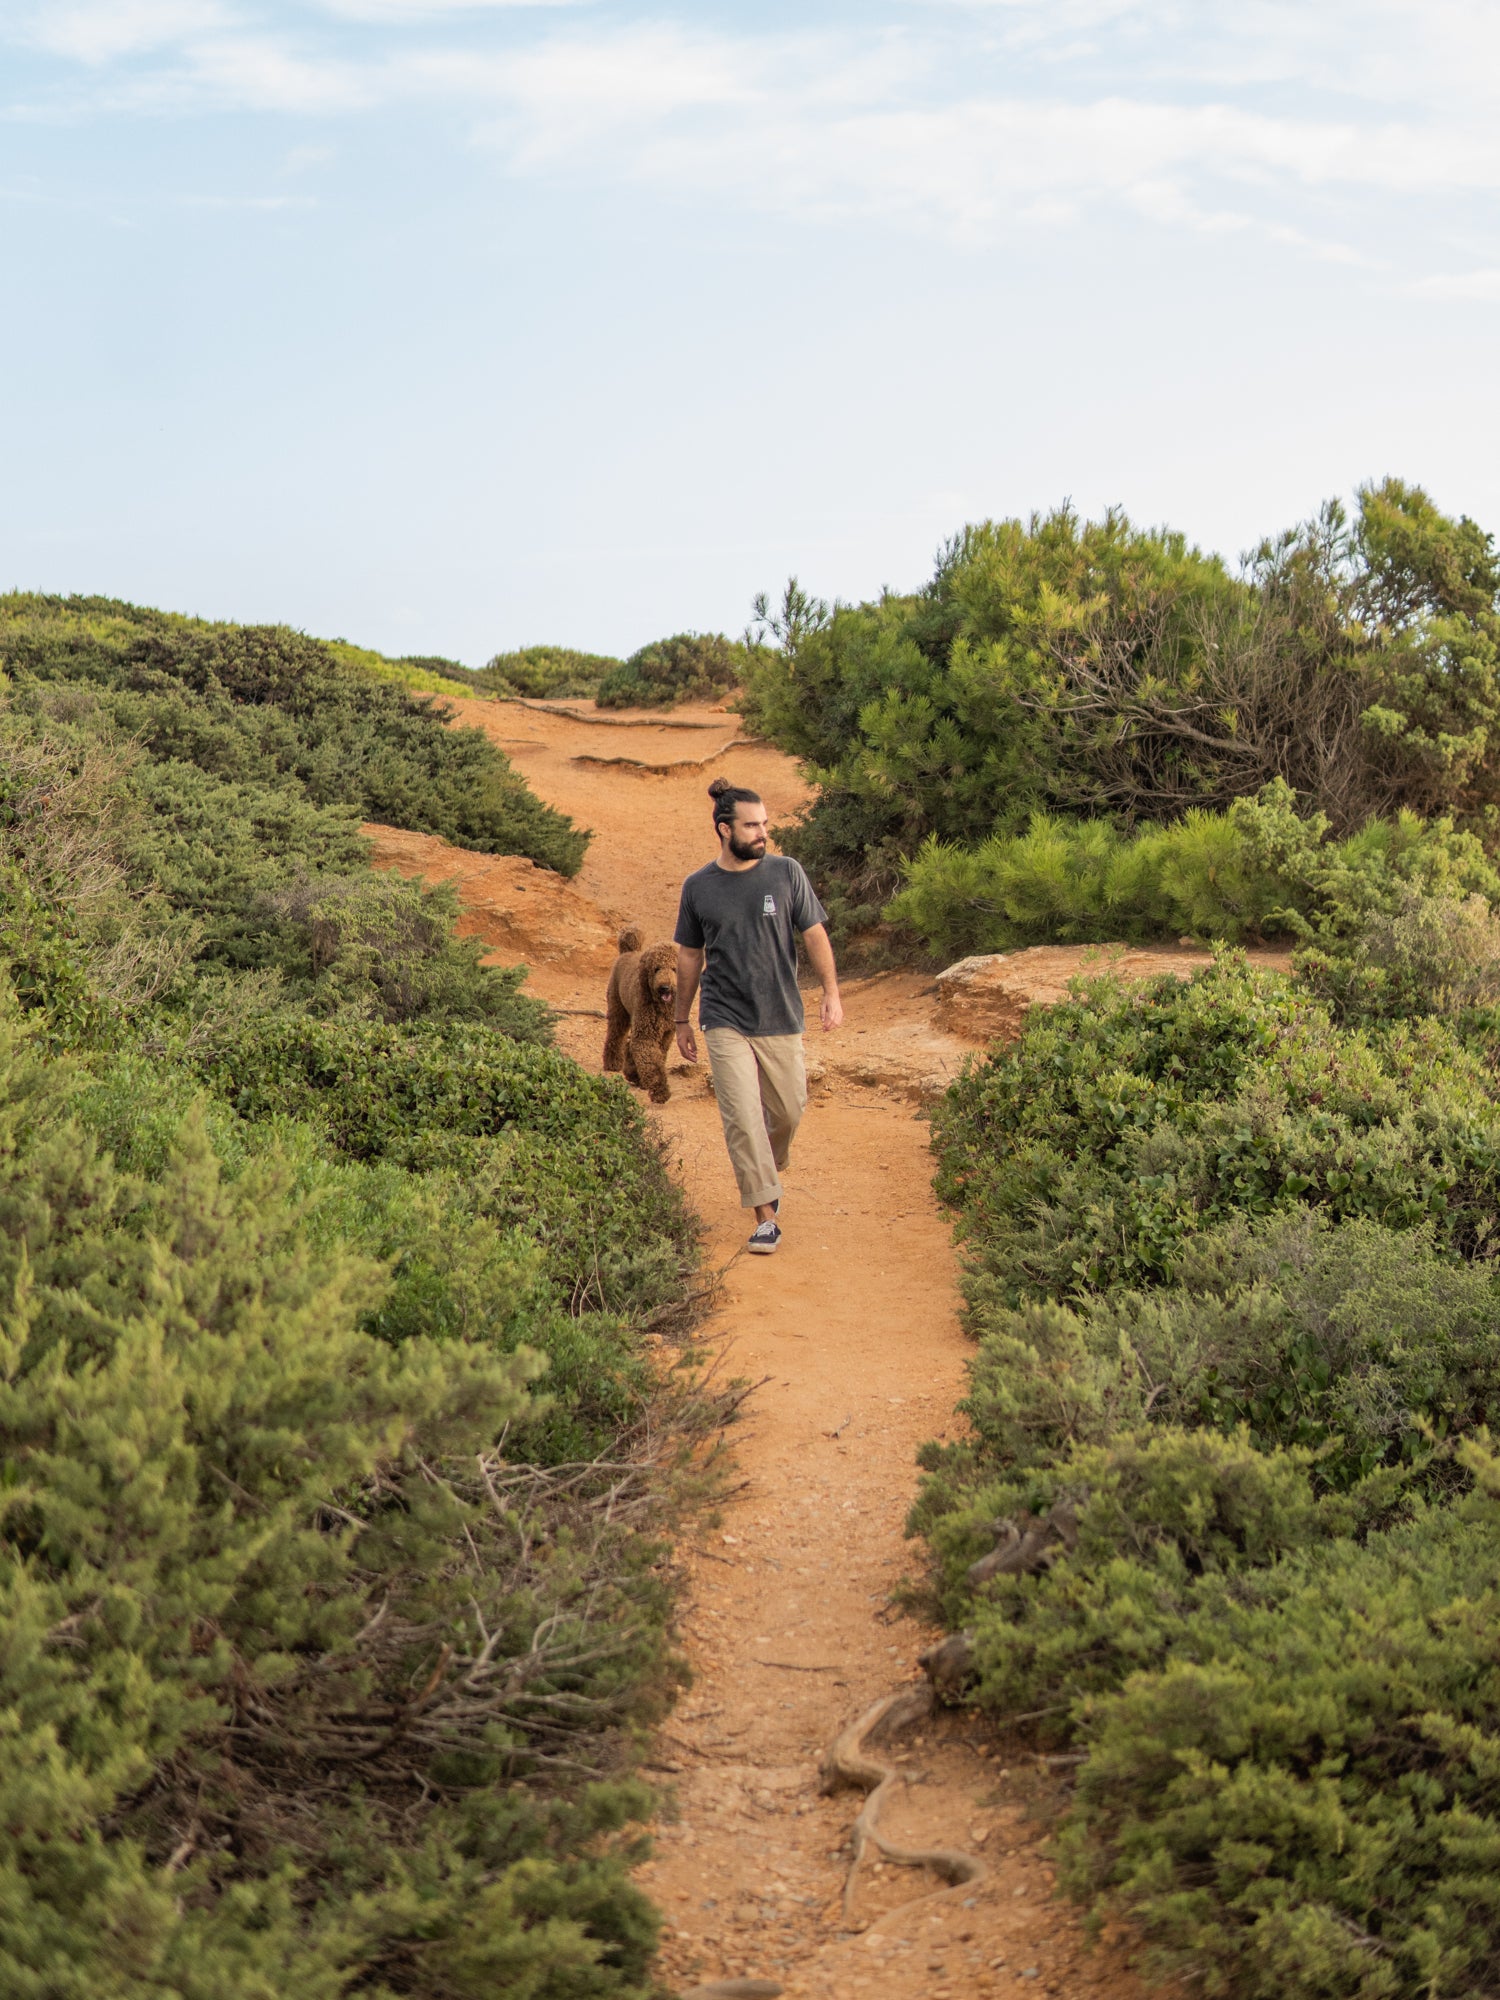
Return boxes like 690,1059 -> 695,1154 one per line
676,778 -> 844,1256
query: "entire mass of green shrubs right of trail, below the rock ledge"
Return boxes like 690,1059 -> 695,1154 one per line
912,944 -> 1500,2000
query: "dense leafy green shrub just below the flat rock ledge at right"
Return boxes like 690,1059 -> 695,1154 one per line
934,958 -> 1500,1304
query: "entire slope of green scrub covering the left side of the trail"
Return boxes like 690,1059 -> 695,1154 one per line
0,598 -> 724,2000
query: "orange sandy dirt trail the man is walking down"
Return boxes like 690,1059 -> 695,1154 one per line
378,702 -> 1144,2000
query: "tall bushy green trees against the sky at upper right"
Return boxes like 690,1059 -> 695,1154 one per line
746,480 -> 1500,938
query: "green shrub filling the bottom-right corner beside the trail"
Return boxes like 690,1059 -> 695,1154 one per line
1066,1454 -> 1500,2000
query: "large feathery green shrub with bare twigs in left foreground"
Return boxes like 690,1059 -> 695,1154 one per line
0,1022 -> 672,2000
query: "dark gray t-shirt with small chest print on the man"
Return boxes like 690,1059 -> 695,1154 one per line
676,854 -> 828,1034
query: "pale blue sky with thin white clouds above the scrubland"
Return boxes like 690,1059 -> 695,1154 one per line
0,0 -> 1500,666
